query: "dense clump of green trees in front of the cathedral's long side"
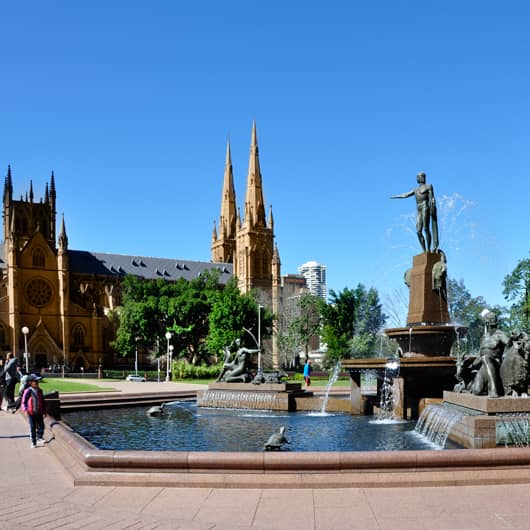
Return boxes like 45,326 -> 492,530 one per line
113,272 -> 272,365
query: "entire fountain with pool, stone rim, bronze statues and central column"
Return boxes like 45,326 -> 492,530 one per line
41,172 -> 530,488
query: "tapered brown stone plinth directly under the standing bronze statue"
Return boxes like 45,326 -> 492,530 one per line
407,252 -> 449,326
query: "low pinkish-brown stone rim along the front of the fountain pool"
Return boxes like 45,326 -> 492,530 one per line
47,412 -> 530,488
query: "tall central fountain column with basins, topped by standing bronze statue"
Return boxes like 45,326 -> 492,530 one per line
343,173 -> 466,418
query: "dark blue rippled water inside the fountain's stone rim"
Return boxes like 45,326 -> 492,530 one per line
62,402 -> 459,452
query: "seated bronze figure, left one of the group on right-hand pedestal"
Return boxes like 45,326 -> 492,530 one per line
471,311 -> 508,397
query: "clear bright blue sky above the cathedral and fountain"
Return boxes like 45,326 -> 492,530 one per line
0,0 -> 530,312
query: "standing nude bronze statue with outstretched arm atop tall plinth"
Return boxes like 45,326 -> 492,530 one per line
390,173 -> 438,252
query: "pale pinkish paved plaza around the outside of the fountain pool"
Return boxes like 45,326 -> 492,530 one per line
0,383 -> 530,530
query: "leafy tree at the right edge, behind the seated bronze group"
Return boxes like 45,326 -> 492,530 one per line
502,255 -> 530,333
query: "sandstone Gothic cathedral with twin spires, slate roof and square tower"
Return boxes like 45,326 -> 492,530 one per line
0,124 -> 304,371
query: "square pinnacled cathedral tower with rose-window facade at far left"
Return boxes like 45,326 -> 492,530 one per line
0,167 -> 63,364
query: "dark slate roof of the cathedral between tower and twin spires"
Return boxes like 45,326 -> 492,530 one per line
68,250 -> 233,284
